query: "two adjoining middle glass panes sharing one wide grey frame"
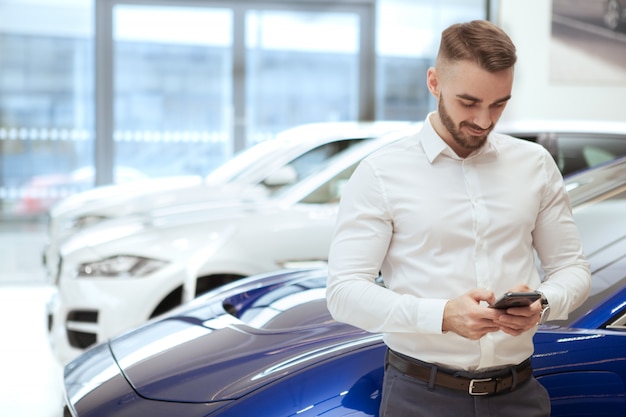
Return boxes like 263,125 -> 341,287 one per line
106,3 -> 359,184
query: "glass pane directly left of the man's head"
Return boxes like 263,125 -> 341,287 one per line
376,0 -> 489,120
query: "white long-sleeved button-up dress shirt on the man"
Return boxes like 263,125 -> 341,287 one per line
327,114 -> 591,370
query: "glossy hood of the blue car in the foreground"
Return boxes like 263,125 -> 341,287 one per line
109,270 -> 372,403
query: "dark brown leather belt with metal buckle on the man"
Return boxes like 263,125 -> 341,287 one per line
387,349 -> 533,395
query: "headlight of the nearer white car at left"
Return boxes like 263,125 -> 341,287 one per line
78,255 -> 168,278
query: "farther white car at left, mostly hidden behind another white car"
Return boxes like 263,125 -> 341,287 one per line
43,121 -> 409,281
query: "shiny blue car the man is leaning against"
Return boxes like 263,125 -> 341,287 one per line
64,159 -> 626,417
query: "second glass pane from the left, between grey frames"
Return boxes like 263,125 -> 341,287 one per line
112,5 -> 233,177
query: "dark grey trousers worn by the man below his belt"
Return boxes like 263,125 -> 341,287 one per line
380,352 -> 550,417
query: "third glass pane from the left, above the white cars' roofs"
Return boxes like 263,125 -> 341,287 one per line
246,10 -> 360,141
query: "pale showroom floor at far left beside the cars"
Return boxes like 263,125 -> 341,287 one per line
0,221 -> 63,417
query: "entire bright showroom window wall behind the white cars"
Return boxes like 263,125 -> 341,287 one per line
0,0 -> 486,218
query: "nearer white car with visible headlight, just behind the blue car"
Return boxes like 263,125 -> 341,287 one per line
48,123 -> 421,363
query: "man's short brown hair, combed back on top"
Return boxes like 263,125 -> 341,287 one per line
437,20 -> 517,72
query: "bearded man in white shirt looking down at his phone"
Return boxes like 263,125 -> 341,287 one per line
327,21 -> 590,417
